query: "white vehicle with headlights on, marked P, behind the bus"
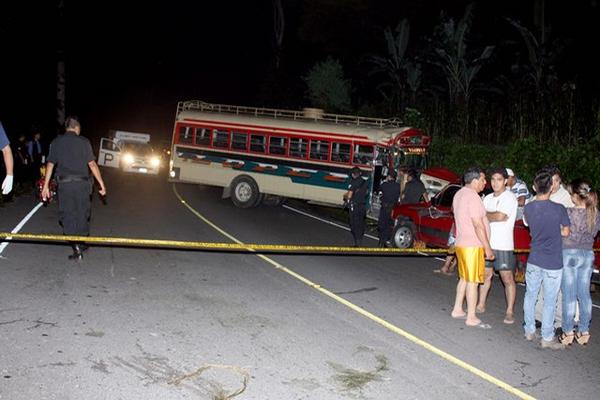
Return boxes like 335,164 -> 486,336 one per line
98,131 -> 161,175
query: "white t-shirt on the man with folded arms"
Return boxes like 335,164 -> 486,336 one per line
483,189 -> 518,251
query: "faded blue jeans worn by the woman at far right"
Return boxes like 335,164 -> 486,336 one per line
561,249 -> 594,333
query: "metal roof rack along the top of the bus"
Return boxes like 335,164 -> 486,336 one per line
177,100 -> 402,128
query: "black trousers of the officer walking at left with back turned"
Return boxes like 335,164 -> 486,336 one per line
58,181 -> 92,236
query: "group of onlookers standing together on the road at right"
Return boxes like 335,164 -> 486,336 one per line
450,166 -> 600,349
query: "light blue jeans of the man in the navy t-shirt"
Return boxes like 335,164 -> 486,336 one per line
523,263 -> 562,341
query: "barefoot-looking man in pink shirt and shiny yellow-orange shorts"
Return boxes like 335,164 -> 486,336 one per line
451,167 -> 494,329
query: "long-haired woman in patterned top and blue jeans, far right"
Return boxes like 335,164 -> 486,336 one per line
559,179 -> 600,345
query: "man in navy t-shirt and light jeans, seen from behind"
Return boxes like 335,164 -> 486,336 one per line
523,169 -> 571,350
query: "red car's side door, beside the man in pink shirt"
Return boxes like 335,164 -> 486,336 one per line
418,185 -> 460,247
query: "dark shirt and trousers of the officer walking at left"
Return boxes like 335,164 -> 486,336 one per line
48,131 -> 95,236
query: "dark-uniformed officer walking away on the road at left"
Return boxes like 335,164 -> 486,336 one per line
42,117 -> 106,260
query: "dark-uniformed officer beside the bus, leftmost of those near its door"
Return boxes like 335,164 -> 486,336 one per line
344,167 -> 368,247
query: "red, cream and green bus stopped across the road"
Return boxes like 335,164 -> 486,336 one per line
169,100 -> 452,209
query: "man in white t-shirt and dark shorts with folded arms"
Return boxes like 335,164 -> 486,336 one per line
477,168 -> 518,324
